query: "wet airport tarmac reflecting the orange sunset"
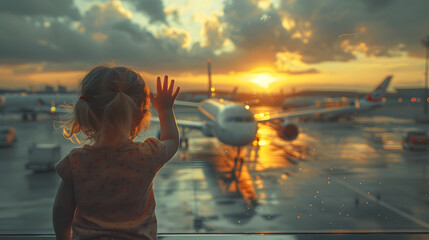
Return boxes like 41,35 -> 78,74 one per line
0,102 -> 429,233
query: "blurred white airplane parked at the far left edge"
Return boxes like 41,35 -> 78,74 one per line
0,93 -> 77,120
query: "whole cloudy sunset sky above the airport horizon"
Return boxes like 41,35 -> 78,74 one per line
0,0 -> 429,92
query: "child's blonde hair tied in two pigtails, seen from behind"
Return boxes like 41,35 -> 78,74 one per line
61,66 -> 150,143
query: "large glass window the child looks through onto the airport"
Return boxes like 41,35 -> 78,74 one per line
0,0 -> 429,237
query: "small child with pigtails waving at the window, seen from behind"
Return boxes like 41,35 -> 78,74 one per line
53,66 -> 180,239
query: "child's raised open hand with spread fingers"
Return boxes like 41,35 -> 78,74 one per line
150,75 -> 180,112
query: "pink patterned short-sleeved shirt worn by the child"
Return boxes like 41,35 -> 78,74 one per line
55,138 -> 167,239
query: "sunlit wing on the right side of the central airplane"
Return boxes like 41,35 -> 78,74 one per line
255,106 -> 359,122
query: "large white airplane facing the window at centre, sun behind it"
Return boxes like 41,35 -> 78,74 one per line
151,61 -> 392,168
